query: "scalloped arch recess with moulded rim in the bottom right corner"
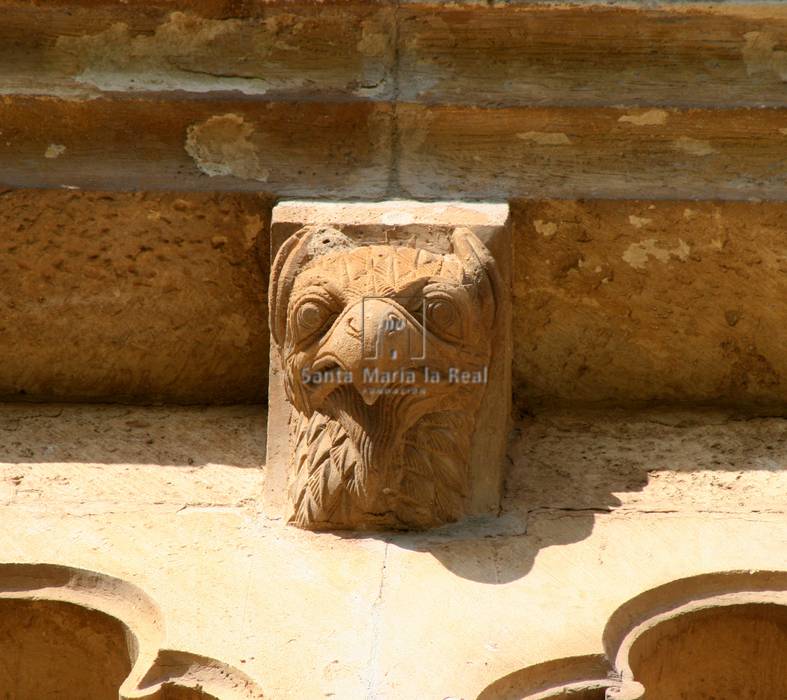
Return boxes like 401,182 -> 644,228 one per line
478,571 -> 787,700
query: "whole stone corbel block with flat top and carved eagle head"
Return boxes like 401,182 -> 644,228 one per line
265,201 -> 511,529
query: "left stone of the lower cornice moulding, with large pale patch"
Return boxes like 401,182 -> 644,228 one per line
0,97 -> 392,197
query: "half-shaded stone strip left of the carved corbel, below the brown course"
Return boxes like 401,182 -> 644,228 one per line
0,403 -> 266,478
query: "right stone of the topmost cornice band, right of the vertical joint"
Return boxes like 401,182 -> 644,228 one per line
398,1 -> 787,107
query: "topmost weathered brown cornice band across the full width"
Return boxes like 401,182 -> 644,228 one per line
0,0 -> 787,107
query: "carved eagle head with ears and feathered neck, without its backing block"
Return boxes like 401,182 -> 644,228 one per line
269,226 -> 500,529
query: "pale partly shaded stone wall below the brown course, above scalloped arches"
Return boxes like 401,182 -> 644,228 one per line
0,405 -> 787,700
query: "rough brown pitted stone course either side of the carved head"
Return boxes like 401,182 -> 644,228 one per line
6,190 -> 787,409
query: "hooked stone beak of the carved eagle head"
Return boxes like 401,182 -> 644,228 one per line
312,297 -> 426,406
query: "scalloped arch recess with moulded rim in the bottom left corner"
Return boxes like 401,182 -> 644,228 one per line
0,564 -> 263,700
